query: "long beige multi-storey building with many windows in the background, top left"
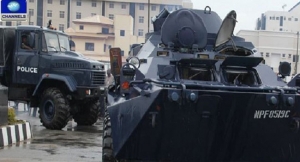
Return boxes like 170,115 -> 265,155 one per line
1,0 -> 193,36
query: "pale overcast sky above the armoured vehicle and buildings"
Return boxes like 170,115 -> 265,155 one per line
192,0 -> 300,34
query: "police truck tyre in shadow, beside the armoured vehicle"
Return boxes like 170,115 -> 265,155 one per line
73,100 -> 100,125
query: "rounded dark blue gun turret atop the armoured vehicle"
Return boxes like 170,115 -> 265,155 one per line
161,9 -> 207,49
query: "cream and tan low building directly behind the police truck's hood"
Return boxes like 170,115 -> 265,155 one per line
65,15 -> 145,62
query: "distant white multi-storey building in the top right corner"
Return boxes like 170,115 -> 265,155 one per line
255,2 -> 300,32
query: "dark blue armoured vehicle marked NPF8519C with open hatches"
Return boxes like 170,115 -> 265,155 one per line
103,7 -> 300,162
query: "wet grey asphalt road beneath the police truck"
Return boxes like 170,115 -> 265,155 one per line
0,106 -> 103,162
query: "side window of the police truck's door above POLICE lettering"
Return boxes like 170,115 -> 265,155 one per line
19,31 -> 38,50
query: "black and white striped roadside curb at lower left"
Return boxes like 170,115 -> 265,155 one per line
0,121 -> 32,147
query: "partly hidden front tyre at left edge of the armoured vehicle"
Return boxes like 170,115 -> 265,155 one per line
102,110 -> 117,162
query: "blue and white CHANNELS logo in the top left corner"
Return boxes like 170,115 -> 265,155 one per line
1,0 -> 27,21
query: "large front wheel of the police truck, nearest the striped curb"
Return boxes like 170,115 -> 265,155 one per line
39,88 -> 70,130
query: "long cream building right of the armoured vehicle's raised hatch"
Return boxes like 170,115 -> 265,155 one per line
237,30 -> 300,74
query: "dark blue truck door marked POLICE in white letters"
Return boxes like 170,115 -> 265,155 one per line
14,30 -> 39,84
